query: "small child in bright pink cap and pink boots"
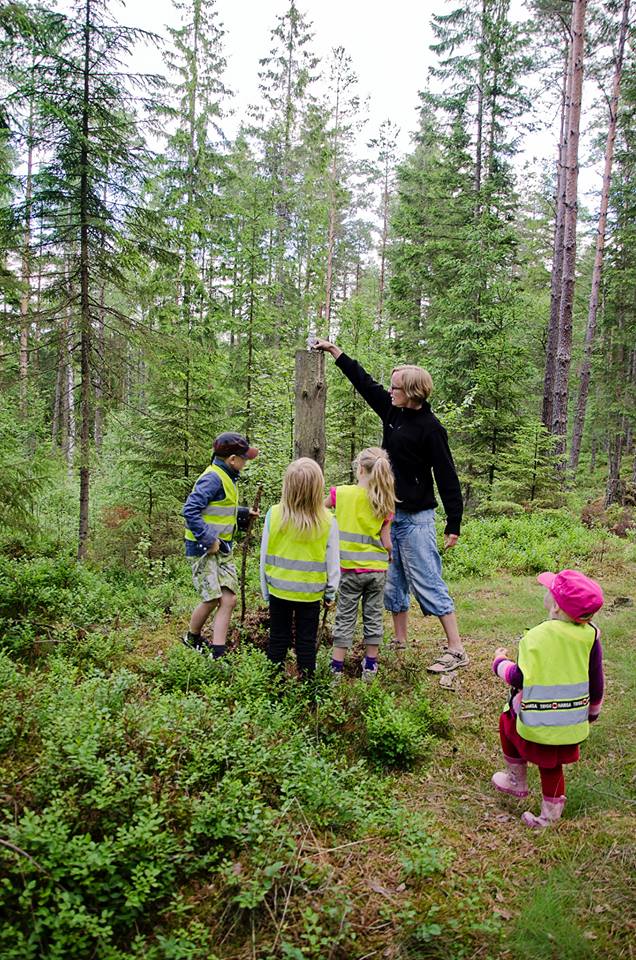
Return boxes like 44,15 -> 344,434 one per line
492,570 -> 603,828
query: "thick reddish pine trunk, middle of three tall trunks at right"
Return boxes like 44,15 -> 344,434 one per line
551,0 -> 587,471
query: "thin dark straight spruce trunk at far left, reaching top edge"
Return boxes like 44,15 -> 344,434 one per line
77,0 -> 92,560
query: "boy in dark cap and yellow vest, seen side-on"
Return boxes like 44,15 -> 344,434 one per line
182,433 -> 258,659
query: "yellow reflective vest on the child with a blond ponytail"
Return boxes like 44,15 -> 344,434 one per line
336,484 -> 389,570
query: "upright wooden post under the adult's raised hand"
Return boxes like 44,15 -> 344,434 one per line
294,350 -> 327,469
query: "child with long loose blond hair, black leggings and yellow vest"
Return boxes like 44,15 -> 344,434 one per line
261,457 -> 340,677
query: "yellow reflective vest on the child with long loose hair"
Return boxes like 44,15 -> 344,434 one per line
265,504 -> 331,601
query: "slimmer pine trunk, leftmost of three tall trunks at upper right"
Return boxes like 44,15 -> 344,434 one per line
541,39 -> 572,430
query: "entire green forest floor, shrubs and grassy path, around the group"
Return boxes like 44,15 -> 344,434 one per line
0,515 -> 636,960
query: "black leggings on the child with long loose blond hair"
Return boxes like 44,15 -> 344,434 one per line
267,596 -> 320,677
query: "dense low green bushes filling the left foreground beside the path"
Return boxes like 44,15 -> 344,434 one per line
0,645 -> 448,960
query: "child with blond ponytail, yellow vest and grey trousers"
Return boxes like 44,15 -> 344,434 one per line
325,447 -> 395,683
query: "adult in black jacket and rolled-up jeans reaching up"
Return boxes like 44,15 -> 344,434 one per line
313,339 -> 469,673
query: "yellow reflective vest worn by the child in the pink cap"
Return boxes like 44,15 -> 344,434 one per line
517,620 -> 596,745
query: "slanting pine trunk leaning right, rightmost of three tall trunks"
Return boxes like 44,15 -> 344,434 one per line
570,0 -> 630,470
